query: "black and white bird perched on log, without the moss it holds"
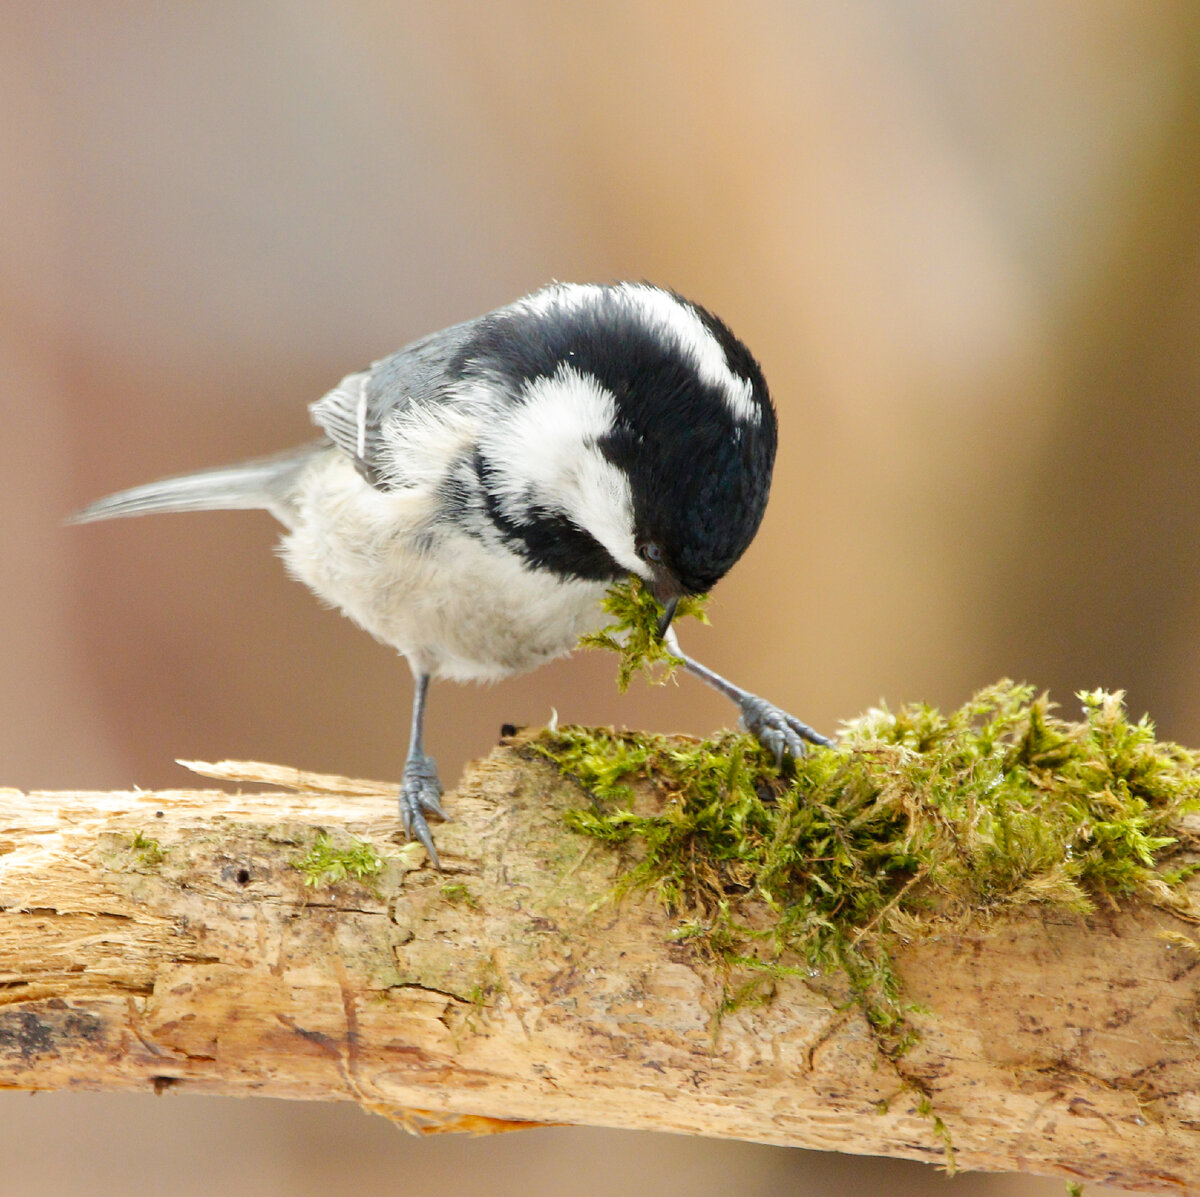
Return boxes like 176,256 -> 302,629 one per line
73,283 -> 828,864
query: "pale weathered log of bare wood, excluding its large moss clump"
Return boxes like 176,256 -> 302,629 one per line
0,742 -> 1200,1192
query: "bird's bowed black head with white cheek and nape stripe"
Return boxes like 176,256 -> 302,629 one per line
463,283 -> 776,630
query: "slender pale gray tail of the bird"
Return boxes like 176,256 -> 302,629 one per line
67,445 -> 323,524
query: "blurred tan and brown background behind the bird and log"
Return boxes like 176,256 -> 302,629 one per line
0,7 -> 1200,1197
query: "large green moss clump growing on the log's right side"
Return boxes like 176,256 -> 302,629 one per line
530,681 -> 1200,1053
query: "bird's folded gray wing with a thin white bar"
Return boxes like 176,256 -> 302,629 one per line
308,320 -> 478,491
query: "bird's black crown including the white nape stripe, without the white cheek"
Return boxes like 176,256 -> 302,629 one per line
461,283 -> 778,594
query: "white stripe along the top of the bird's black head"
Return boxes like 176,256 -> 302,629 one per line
517,283 -> 762,423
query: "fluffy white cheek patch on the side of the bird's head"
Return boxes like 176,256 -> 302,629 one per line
479,363 -> 646,576
